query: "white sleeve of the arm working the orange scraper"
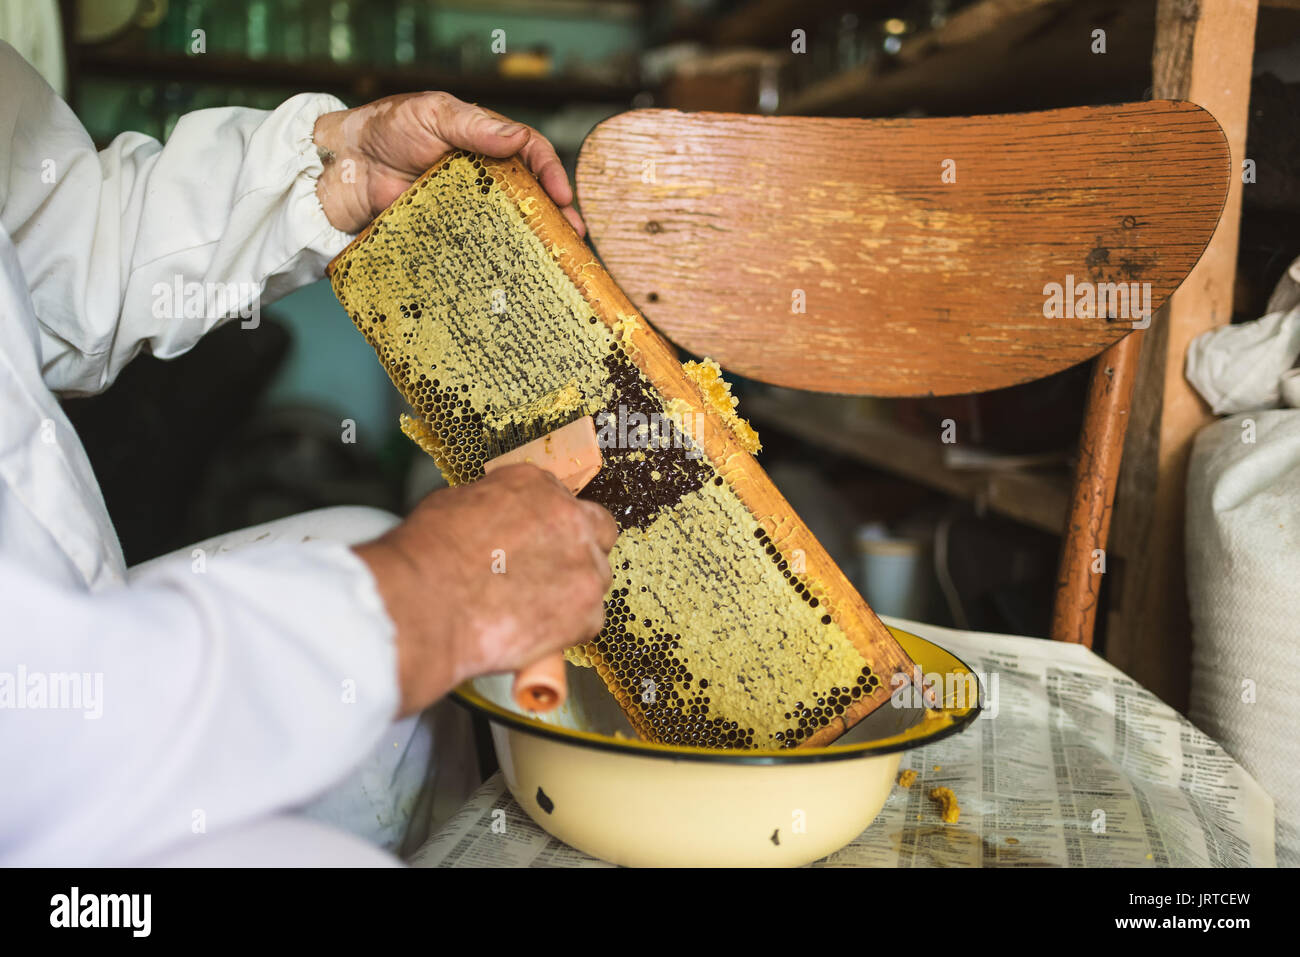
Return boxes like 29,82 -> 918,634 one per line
0,542 -> 399,866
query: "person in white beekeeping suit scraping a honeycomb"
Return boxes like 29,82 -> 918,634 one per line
0,43 -> 616,865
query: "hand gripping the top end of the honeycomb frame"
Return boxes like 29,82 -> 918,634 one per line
313,92 -> 586,235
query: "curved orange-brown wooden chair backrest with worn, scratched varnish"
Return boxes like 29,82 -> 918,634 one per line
577,101 -> 1229,395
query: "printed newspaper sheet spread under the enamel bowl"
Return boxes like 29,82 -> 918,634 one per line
411,620 -> 1275,867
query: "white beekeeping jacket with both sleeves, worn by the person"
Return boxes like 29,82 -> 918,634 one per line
0,43 -> 398,865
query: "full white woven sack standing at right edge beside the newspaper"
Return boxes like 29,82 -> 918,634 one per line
1187,410 -> 1300,866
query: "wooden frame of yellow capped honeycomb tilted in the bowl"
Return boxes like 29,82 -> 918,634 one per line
326,152 -> 913,750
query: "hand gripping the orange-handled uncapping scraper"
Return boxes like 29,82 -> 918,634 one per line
355,465 -> 619,715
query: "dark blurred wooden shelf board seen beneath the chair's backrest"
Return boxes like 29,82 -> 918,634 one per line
738,393 -> 1070,534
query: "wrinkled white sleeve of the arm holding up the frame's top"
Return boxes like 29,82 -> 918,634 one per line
0,42 -> 351,394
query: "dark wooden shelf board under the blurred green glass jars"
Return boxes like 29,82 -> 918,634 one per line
75,48 -> 644,105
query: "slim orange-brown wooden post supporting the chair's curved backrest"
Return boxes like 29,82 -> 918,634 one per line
1052,332 -> 1143,648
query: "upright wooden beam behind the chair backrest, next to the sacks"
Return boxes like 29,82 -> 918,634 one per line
1105,0 -> 1257,710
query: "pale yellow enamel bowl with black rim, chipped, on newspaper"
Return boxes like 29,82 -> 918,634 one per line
455,628 -> 979,867
